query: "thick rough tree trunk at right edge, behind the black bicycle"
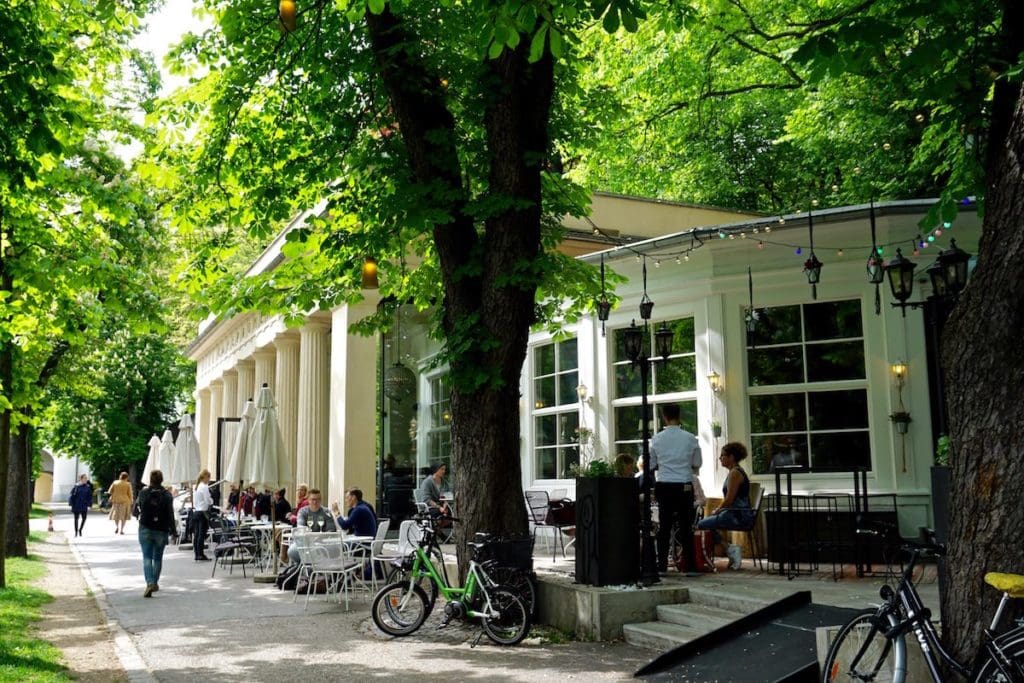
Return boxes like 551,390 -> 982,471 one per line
942,2 -> 1024,660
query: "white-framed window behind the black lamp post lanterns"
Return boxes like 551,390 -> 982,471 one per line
611,317 -> 697,456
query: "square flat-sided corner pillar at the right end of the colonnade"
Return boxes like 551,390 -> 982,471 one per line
328,301 -> 380,501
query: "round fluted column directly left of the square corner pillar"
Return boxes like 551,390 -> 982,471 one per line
295,319 -> 331,491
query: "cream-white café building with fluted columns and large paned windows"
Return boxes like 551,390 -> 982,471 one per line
188,194 -> 980,535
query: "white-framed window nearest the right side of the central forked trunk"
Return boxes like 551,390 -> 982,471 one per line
532,339 -> 580,479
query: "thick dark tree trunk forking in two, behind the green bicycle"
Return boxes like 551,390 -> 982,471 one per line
367,10 -> 554,566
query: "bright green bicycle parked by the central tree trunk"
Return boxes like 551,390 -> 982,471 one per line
371,516 -> 530,645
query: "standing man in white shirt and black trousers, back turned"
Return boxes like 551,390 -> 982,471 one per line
648,403 -> 700,577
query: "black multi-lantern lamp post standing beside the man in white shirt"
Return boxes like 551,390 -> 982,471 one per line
623,262 -> 675,586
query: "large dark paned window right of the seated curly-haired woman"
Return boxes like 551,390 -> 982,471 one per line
746,300 -> 871,474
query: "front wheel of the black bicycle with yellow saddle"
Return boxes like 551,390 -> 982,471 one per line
821,609 -> 906,683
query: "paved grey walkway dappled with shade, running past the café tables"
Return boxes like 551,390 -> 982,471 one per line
41,511 -> 651,683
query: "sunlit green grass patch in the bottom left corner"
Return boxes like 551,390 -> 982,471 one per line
0,552 -> 72,683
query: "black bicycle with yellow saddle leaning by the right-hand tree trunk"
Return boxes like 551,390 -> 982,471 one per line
822,529 -> 1024,683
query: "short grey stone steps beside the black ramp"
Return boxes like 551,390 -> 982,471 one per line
623,588 -> 772,652
